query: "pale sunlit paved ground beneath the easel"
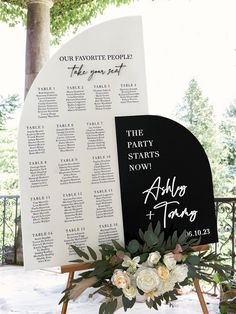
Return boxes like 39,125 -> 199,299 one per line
0,266 -> 219,314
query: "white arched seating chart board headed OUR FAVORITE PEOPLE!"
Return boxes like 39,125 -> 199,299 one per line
18,17 -> 147,269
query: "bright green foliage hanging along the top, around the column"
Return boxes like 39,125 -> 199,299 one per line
0,0 -> 132,41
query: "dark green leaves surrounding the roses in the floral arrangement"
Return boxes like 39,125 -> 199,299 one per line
58,222 -> 232,314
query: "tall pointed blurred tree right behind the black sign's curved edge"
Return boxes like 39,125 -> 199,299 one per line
176,79 -> 226,197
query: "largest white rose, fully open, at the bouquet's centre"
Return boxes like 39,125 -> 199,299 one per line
136,268 -> 160,292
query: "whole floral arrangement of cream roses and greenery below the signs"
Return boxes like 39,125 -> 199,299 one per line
60,222 -> 229,314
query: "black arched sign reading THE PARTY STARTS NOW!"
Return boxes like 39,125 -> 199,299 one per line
116,115 -> 218,244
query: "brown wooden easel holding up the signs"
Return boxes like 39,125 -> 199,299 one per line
61,244 -> 209,314
